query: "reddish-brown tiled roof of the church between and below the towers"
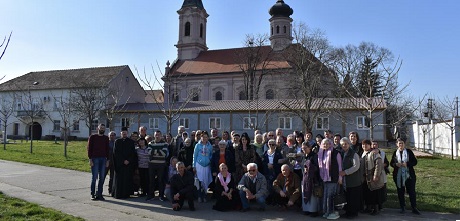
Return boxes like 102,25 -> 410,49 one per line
170,46 -> 292,75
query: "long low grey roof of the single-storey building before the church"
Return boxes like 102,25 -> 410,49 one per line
117,98 -> 386,112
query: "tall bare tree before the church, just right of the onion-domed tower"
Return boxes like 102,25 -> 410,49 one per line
281,23 -> 336,131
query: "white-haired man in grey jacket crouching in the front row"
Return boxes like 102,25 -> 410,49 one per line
238,163 -> 268,212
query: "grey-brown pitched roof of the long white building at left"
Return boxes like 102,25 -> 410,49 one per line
0,65 -> 129,91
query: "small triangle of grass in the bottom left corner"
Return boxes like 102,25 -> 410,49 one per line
0,192 -> 84,221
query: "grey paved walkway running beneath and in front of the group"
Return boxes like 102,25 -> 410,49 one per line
0,160 -> 460,221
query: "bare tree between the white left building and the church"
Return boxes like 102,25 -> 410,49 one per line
136,61 -> 201,133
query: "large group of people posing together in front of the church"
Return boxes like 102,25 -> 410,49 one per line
88,124 -> 420,219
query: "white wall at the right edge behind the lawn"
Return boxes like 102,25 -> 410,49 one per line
407,117 -> 460,159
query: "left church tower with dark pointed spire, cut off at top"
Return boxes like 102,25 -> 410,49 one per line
176,0 -> 209,60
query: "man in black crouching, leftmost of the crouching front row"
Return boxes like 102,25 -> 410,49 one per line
171,161 -> 195,211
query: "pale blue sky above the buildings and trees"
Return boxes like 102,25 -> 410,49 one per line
0,0 -> 460,98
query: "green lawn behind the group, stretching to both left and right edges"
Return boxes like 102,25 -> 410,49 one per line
0,141 -> 460,213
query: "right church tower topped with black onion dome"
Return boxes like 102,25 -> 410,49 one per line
269,0 -> 294,51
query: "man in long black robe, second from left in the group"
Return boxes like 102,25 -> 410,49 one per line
112,127 -> 137,199
